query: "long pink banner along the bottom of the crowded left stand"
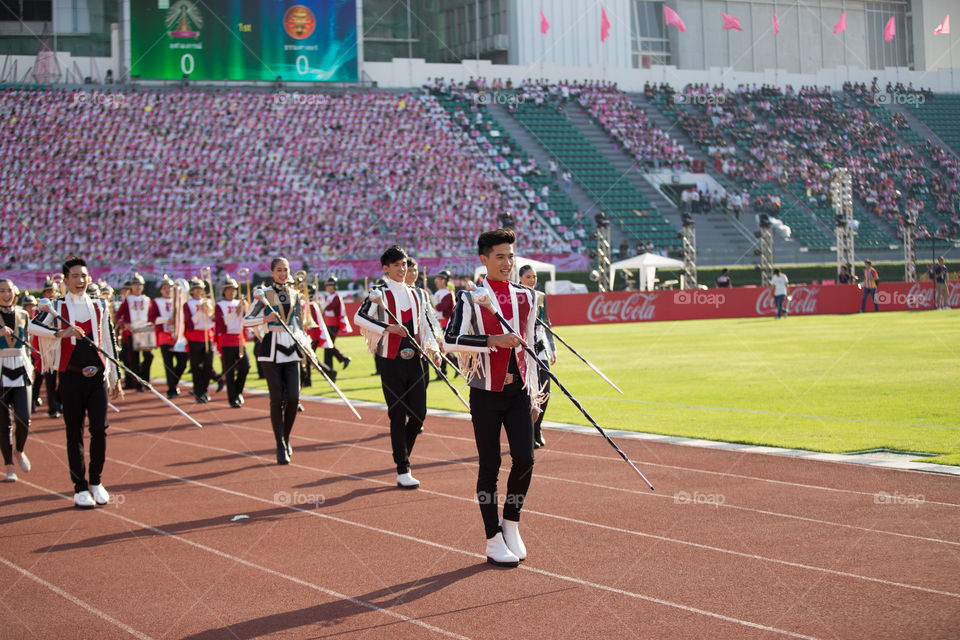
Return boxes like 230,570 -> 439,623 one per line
0,253 -> 590,289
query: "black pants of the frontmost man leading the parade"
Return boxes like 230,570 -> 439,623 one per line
470,382 -> 533,538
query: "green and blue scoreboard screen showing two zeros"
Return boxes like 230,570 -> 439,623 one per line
130,0 -> 358,82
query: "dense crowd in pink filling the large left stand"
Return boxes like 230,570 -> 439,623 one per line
0,88 -> 558,268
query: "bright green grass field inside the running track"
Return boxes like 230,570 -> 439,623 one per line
227,311 -> 960,465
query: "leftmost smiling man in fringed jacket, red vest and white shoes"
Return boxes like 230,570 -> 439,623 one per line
29,258 -> 123,509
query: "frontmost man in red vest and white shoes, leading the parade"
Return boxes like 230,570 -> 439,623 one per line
444,229 -> 540,567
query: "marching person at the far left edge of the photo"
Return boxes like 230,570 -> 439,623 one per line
0,278 -> 33,482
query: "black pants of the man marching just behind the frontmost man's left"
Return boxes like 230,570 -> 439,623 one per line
376,355 -> 427,473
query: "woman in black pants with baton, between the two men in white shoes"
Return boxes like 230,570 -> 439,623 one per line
243,258 -> 309,464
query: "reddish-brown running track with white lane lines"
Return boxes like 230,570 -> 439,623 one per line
0,394 -> 960,639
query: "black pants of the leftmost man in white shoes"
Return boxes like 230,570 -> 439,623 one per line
60,371 -> 109,493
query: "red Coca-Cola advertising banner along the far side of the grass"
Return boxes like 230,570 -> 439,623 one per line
347,282 -> 960,338
